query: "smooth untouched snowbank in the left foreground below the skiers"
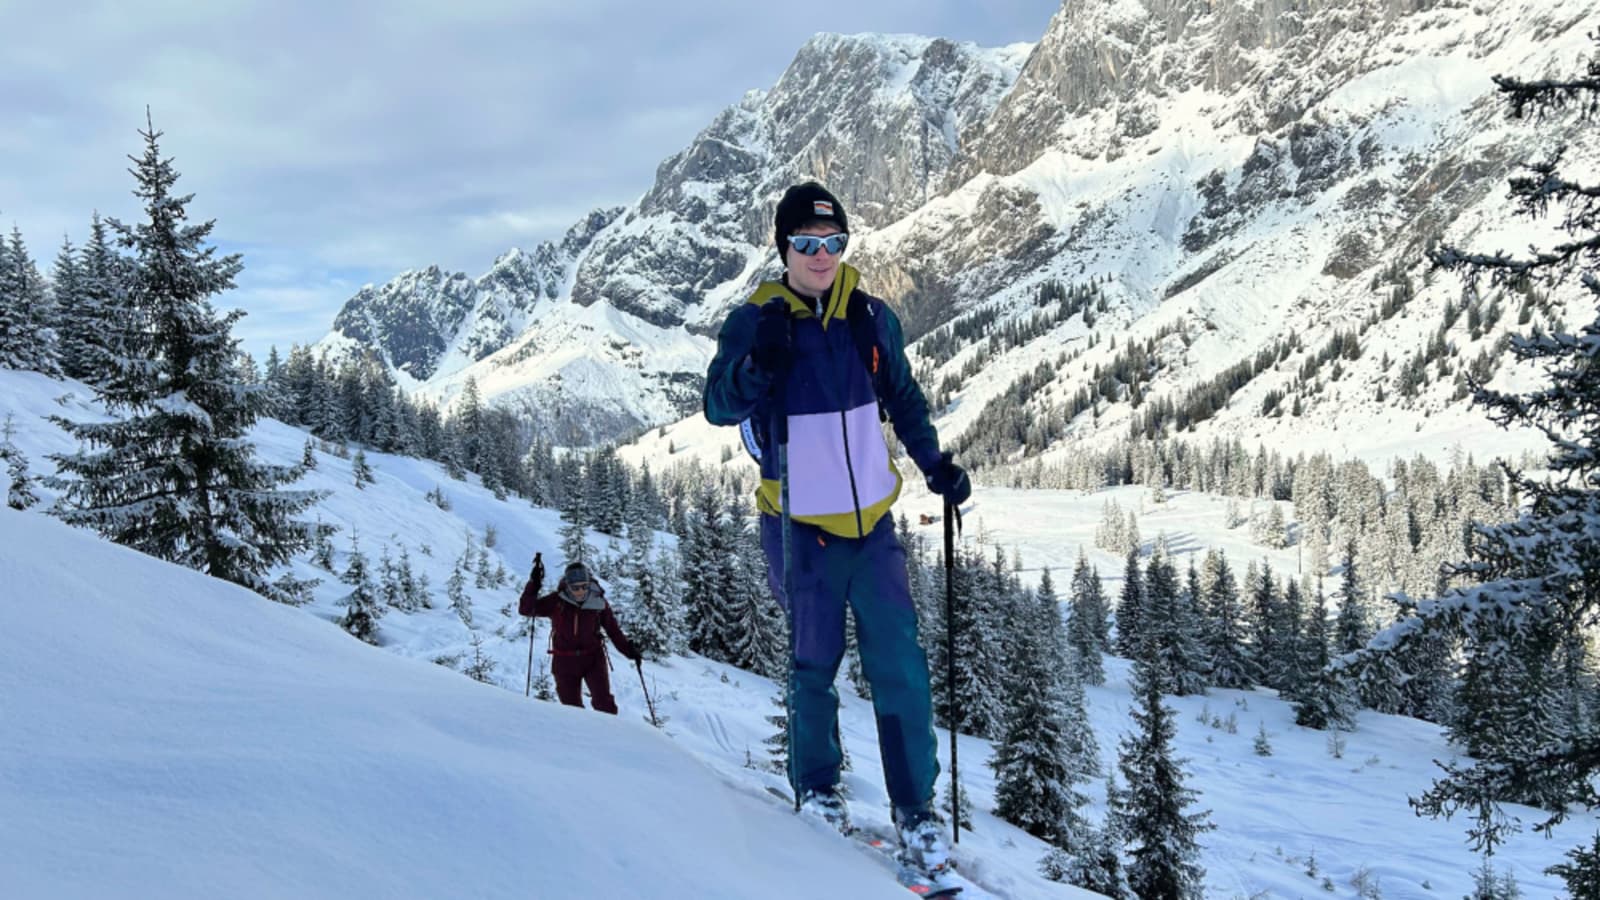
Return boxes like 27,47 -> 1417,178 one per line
0,509 -> 934,900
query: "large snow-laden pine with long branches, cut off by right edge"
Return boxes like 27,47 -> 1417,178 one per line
1368,35 -> 1600,850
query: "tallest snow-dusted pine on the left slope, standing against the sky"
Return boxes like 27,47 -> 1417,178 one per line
51,117 -> 318,597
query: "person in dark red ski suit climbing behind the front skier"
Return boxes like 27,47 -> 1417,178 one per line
517,562 -> 645,716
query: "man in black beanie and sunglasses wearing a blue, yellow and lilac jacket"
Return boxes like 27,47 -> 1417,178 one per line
704,181 -> 971,876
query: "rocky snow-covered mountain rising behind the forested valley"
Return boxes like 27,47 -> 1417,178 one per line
318,0 -> 1600,460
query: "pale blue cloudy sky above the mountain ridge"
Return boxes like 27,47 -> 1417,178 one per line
0,0 -> 1059,356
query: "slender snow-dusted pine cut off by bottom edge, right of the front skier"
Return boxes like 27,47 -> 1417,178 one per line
1112,643 -> 1213,900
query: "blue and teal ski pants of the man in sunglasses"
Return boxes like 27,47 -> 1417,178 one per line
762,516 -> 939,812
